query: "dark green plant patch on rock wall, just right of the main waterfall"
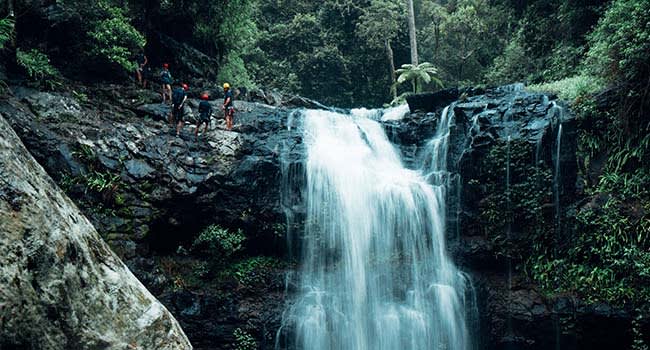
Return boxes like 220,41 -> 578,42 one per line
468,139 -> 554,259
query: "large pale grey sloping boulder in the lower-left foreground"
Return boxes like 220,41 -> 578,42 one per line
0,117 -> 192,350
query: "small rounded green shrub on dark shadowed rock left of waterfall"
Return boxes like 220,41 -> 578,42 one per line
191,225 -> 246,262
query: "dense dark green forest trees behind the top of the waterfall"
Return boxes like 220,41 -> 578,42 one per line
3,0 -> 636,106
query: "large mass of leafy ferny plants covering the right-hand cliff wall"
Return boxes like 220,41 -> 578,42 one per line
528,91 -> 650,308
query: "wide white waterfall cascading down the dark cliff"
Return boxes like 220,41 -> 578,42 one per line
277,110 -> 468,350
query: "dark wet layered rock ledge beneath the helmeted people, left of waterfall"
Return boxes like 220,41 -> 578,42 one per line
0,89 -> 301,258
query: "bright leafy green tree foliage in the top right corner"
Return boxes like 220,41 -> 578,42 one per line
586,0 -> 650,82
